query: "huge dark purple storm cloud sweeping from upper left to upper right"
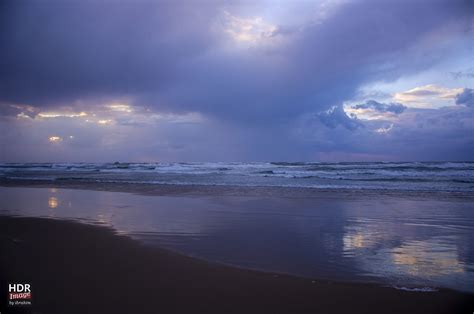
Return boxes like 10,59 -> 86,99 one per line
0,1 -> 469,119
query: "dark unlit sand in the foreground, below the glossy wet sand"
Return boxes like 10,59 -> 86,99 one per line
0,216 -> 474,314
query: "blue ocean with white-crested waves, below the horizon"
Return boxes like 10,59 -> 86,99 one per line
0,162 -> 474,192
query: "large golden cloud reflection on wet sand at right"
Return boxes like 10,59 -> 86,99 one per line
342,223 -> 464,288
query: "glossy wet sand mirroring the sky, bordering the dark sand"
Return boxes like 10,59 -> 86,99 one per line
0,188 -> 474,292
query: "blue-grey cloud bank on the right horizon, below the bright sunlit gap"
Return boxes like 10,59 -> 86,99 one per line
297,106 -> 474,161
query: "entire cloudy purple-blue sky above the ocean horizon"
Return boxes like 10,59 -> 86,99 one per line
0,0 -> 474,162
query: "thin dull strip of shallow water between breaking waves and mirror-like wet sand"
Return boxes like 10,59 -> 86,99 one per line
0,178 -> 474,201
